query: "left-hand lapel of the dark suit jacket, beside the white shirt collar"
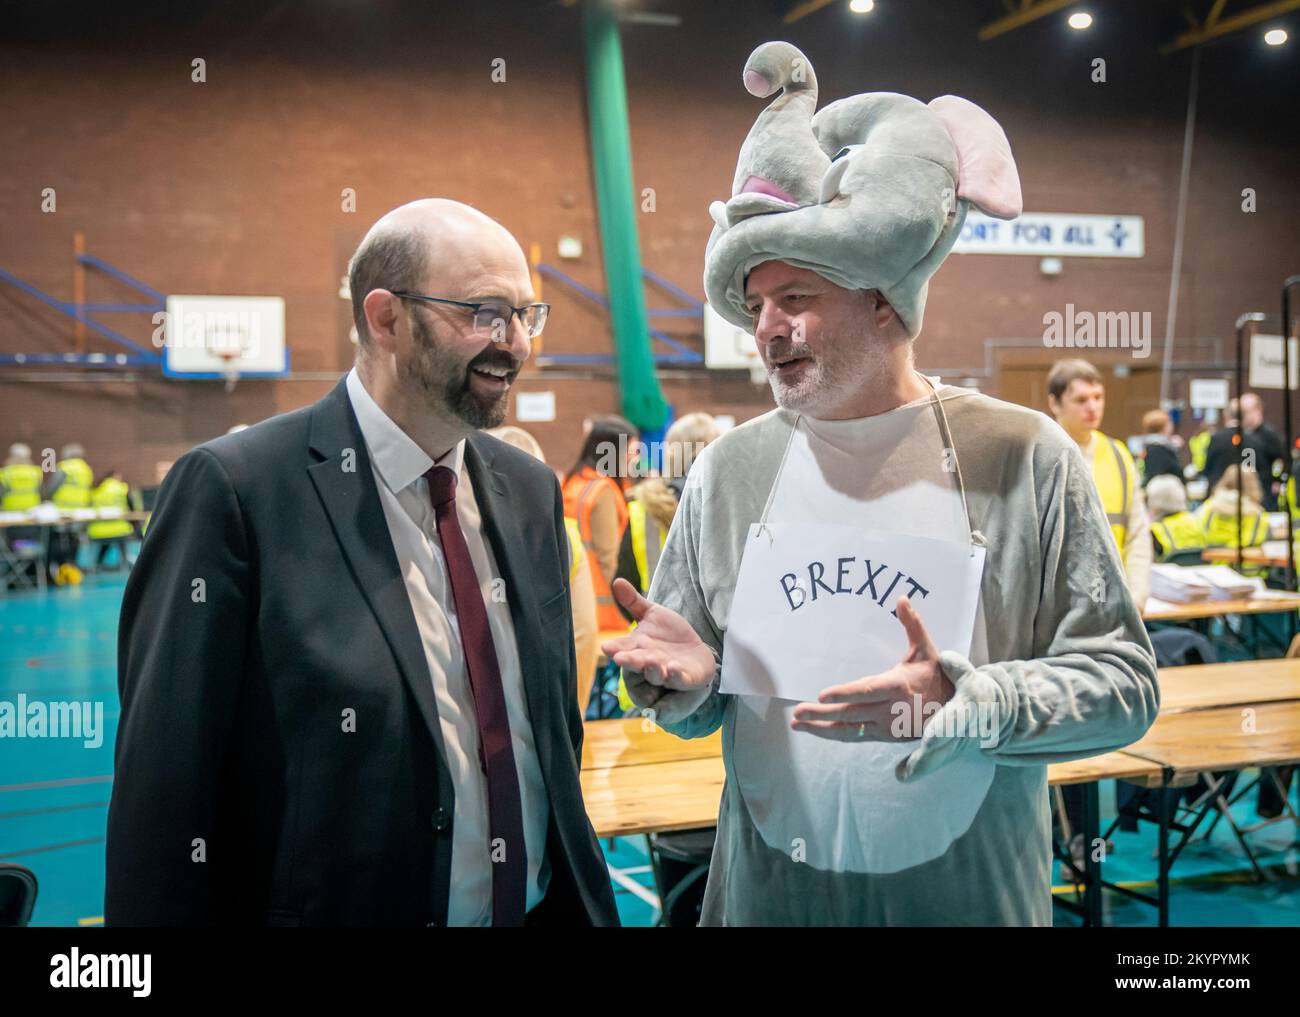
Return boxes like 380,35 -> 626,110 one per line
307,380 -> 447,767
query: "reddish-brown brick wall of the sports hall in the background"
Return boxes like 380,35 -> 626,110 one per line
0,3 -> 1300,482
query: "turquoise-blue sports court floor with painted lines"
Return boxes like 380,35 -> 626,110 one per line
0,574 -> 1300,926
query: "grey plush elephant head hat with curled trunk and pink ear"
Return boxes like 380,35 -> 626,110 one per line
705,42 -> 1021,338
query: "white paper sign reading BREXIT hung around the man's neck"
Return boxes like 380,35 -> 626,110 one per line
719,523 -> 984,702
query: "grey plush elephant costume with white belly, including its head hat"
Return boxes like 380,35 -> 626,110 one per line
624,43 -> 1160,925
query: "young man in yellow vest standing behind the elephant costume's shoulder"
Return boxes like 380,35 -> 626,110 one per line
1048,360 -> 1152,613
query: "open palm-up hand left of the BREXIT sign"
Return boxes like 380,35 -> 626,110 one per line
601,579 -> 716,692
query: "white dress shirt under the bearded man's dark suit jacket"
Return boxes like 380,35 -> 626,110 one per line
347,368 -> 550,925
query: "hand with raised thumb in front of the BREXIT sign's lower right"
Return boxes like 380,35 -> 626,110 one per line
790,597 -> 956,741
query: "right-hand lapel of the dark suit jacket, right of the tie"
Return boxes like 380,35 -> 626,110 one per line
465,433 -> 551,786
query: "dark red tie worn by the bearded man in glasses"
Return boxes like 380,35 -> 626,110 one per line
424,466 -> 528,926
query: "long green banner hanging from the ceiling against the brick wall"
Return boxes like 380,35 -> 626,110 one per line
586,0 -> 668,432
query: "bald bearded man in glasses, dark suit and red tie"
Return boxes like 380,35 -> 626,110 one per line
105,199 -> 618,926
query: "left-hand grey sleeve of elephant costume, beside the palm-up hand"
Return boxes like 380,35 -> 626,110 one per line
623,462 -> 727,737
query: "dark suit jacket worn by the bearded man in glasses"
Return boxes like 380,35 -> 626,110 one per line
104,382 -> 618,926
